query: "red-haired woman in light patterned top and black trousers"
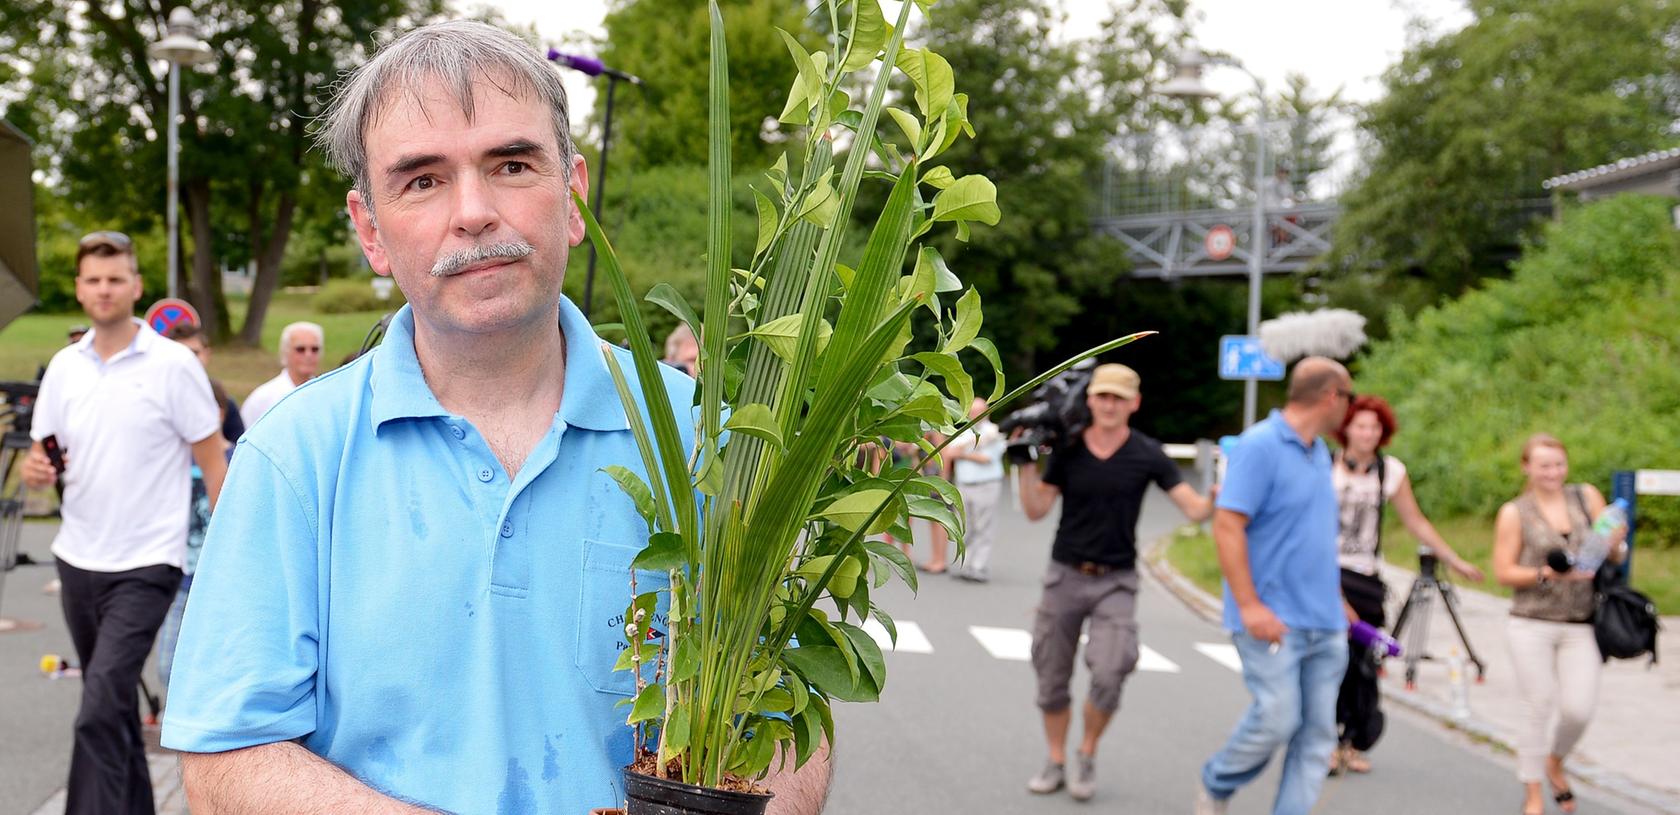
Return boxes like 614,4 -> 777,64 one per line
1331,397 -> 1482,773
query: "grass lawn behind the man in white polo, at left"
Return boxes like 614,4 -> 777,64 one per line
0,292 -> 394,402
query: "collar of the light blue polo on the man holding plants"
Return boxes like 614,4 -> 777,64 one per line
370,297 -> 638,430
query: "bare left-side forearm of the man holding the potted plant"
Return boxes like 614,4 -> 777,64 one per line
181,741 -> 440,815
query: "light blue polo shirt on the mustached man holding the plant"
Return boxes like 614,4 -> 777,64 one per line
163,301 -> 694,815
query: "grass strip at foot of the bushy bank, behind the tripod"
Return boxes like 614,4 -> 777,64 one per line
1166,518 -> 1680,615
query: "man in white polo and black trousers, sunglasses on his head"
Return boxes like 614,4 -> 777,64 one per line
24,232 -> 227,815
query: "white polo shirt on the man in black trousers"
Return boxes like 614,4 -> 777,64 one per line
30,319 -> 222,571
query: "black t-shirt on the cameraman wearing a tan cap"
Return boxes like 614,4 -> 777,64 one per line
1043,430 -> 1183,570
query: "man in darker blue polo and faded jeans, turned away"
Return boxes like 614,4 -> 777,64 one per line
1196,356 -> 1354,815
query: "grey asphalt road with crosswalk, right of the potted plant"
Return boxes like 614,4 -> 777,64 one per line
827,492 -> 1641,815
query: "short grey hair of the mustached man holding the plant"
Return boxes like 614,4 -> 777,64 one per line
316,20 -> 576,212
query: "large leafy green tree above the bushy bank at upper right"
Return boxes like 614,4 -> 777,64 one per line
1331,0 -> 1680,316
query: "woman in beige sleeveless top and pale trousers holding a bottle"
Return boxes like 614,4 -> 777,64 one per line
1494,434 -> 1626,815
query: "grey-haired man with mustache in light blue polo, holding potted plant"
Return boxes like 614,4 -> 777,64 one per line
163,22 -> 828,815
